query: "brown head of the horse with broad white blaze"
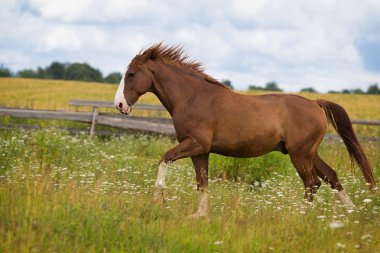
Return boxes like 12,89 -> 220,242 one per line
114,55 -> 153,114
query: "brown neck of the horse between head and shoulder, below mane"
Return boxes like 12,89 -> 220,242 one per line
153,64 -> 202,115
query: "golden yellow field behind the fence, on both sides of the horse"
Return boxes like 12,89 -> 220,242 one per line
0,78 -> 380,120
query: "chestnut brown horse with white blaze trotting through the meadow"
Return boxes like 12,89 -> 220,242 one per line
114,42 -> 376,218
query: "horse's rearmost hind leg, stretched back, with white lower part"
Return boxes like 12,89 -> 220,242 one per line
313,154 -> 355,208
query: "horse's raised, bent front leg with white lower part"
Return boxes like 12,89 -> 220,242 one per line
153,137 -> 204,204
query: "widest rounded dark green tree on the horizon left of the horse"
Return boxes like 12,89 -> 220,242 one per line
65,63 -> 103,82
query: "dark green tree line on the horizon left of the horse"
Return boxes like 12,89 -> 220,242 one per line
0,62 -> 122,83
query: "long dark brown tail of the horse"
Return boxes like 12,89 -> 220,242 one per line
316,99 -> 376,191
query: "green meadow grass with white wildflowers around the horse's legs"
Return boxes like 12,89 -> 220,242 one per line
0,128 -> 380,252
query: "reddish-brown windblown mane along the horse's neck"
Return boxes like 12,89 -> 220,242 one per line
139,42 -> 228,89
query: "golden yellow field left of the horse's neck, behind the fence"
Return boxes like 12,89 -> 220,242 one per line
0,78 -> 160,110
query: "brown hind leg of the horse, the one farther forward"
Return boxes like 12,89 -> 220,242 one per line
290,154 -> 321,201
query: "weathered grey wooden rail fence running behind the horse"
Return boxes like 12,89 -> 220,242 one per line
0,100 -> 380,136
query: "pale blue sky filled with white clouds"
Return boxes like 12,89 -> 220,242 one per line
0,0 -> 380,92
